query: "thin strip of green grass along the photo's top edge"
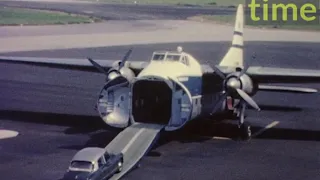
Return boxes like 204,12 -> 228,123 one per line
86,0 -> 245,6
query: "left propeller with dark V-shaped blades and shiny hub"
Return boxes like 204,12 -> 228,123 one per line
87,48 -> 132,79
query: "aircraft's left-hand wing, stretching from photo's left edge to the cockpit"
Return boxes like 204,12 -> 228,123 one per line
0,56 -> 149,73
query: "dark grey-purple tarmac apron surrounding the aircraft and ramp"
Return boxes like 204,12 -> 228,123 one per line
0,42 -> 320,179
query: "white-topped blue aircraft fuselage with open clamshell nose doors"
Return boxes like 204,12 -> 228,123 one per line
98,52 -> 229,131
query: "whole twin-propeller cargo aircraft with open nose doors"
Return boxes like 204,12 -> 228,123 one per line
0,4 -> 320,139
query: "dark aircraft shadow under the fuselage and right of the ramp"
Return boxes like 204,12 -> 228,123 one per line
147,117 -> 320,157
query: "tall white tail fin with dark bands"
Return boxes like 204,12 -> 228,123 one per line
219,4 -> 244,68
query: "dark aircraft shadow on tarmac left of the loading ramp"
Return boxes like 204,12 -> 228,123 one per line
0,110 -> 122,154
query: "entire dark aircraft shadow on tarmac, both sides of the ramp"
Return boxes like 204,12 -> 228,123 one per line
0,108 -> 320,156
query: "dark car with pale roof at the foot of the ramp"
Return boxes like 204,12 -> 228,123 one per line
63,147 -> 123,180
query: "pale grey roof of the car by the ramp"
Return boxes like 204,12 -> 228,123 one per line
72,147 -> 106,162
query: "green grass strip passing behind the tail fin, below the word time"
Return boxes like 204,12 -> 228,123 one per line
190,15 -> 320,31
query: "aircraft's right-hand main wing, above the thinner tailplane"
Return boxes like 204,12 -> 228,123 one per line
247,66 -> 320,83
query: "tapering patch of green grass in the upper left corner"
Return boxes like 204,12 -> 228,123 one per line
0,7 -> 97,25
